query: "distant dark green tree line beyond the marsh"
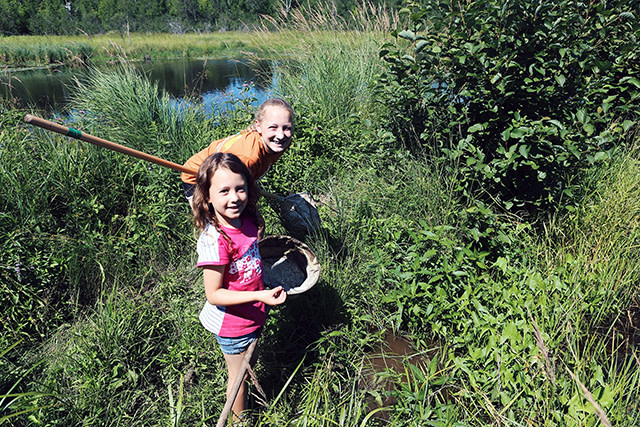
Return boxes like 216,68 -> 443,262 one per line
0,0 -> 402,36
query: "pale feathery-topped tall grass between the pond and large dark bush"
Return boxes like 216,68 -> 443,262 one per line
254,2 -> 397,131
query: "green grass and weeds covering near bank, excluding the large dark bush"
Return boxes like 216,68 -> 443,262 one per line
0,6 -> 640,426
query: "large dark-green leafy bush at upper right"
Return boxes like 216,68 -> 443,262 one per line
378,0 -> 640,211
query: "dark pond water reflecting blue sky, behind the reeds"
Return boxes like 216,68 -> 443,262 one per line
0,59 -> 271,112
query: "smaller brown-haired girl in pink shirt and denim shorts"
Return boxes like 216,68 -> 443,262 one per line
193,153 -> 287,420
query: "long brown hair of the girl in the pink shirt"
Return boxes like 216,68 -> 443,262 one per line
193,153 -> 264,237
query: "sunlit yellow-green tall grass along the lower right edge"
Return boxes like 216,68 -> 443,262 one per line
546,150 -> 640,425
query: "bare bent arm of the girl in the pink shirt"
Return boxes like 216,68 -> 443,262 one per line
202,265 -> 287,306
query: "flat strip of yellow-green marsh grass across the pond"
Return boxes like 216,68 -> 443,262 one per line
0,29 -> 384,70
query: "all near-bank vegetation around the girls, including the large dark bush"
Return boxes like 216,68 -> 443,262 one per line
0,0 -> 640,426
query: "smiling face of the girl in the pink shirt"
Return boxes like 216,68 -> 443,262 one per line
207,168 -> 249,228
